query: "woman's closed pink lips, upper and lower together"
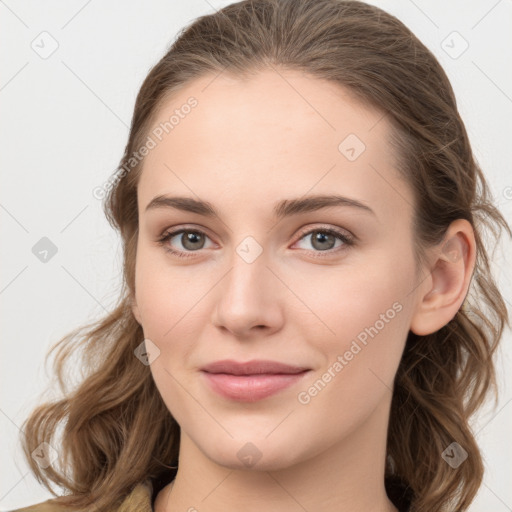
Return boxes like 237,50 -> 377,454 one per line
201,360 -> 310,402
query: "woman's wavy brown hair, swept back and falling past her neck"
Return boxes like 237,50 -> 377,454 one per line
19,0 -> 512,512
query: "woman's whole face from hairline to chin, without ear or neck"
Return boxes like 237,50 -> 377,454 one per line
133,70 -> 424,469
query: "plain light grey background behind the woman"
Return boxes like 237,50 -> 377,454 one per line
0,0 -> 512,512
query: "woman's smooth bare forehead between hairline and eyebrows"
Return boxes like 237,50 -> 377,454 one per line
138,70 -> 412,221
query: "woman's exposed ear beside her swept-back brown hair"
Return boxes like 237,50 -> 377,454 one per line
410,219 -> 476,336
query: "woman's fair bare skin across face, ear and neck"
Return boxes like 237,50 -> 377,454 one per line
133,69 -> 475,512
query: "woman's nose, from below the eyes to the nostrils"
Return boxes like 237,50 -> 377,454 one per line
212,249 -> 284,339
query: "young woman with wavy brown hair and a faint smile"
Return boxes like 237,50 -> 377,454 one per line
10,0 -> 512,512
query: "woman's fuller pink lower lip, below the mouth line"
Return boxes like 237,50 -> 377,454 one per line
202,370 -> 309,402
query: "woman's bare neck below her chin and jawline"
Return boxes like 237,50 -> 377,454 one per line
155,400 -> 397,512
